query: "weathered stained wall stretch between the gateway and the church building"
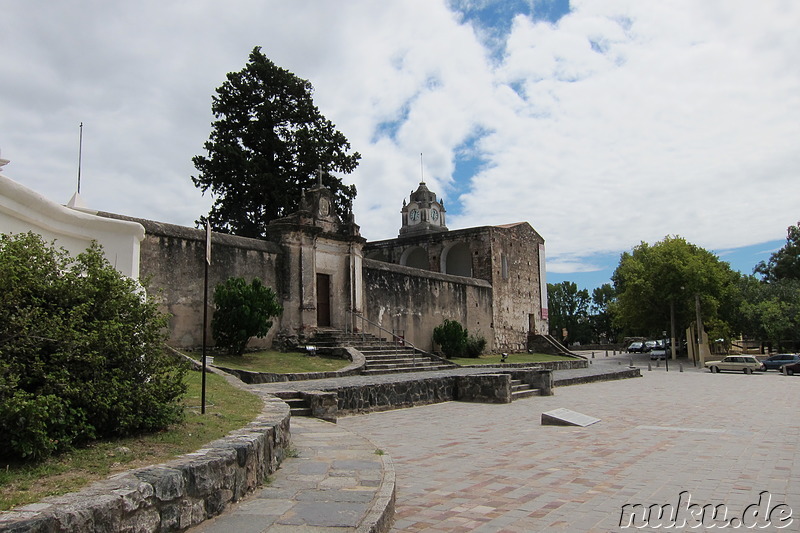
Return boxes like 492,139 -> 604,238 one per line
363,259 -> 494,351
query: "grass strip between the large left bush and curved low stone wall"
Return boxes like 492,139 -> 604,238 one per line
0,372 -> 263,510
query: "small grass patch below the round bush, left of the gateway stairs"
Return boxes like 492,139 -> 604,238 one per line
196,350 -> 350,374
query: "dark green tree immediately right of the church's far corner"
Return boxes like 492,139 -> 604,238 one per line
547,281 -> 592,343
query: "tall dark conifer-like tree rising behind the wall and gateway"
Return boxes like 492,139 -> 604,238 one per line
192,47 -> 361,237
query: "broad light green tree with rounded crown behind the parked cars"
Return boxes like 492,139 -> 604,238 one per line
610,236 -> 739,336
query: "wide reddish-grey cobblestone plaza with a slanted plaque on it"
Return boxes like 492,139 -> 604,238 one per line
339,364 -> 800,532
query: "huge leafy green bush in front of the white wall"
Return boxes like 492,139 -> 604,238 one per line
0,233 -> 185,458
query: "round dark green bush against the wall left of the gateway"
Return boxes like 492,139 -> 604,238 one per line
211,278 -> 283,355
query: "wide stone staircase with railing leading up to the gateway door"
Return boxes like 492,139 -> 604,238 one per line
312,330 -> 458,375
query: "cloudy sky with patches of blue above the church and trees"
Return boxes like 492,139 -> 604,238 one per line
0,0 -> 800,289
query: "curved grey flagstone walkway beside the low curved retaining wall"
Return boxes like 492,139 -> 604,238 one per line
190,417 -> 394,533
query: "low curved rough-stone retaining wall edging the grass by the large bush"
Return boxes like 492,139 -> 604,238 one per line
0,378 -> 290,532
